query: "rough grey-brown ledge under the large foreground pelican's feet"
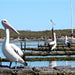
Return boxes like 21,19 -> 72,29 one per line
0,66 -> 75,75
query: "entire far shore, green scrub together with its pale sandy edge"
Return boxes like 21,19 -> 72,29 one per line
0,29 -> 75,41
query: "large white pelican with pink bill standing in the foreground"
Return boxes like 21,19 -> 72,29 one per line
1,19 -> 27,68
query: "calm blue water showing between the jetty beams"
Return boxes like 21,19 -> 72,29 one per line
0,41 -> 75,67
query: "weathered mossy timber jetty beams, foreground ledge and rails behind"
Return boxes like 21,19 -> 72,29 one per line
0,41 -> 75,75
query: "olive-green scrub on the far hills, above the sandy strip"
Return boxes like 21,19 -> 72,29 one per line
0,29 -> 75,39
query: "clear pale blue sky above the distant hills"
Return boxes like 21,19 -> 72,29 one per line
0,0 -> 75,31
